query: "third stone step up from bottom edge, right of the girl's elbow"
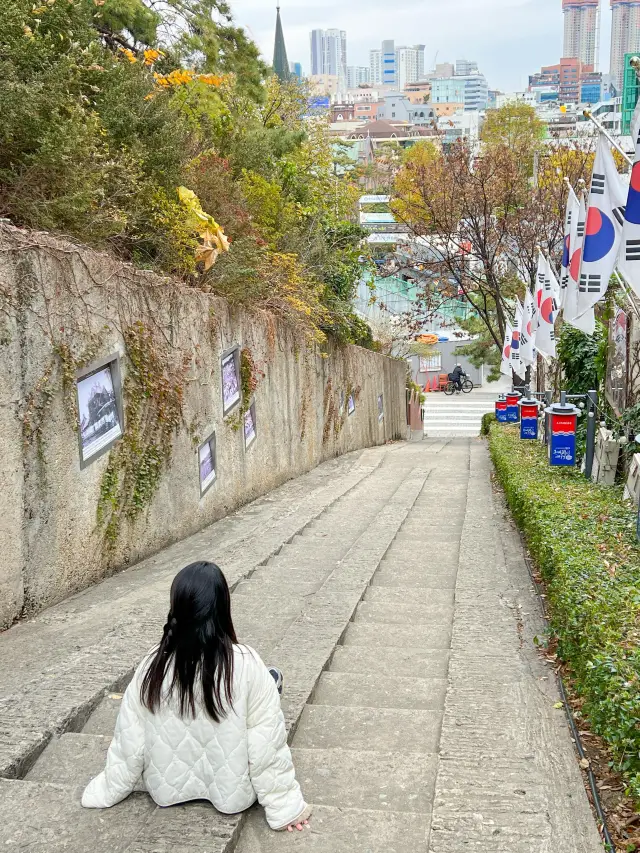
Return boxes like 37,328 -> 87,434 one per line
293,705 -> 442,755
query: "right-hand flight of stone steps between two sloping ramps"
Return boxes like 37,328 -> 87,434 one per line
236,446 -> 468,853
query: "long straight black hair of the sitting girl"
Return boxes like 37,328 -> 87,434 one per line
140,563 -> 238,723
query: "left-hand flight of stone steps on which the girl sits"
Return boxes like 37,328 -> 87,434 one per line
0,445 -> 442,853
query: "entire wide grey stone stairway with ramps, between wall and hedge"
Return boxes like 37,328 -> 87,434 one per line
0,439 -> 602,853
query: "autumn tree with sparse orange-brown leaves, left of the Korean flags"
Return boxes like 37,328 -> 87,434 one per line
394,110 -> 589,372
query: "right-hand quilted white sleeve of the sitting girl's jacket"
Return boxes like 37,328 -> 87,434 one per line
247,656 -> 307,829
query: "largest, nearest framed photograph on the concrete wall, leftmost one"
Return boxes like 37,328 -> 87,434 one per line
76,353 -> 124,468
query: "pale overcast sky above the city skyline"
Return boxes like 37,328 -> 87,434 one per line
231,0 -> 611,92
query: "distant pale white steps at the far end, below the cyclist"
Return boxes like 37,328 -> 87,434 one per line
424,390 -> 496,438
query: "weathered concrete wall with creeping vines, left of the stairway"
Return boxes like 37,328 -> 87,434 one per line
0,226 -> 406,627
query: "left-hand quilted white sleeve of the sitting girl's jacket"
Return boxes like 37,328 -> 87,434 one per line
82,677 -> 144,809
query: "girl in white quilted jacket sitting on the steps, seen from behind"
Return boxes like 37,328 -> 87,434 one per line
82,563 -> 310,832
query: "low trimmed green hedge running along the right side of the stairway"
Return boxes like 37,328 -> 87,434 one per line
489,424 -> 640,800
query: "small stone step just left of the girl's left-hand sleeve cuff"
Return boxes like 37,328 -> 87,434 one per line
25,732 -> 111,788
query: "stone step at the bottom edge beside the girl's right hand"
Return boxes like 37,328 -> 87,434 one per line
232,805 -> 430,853
